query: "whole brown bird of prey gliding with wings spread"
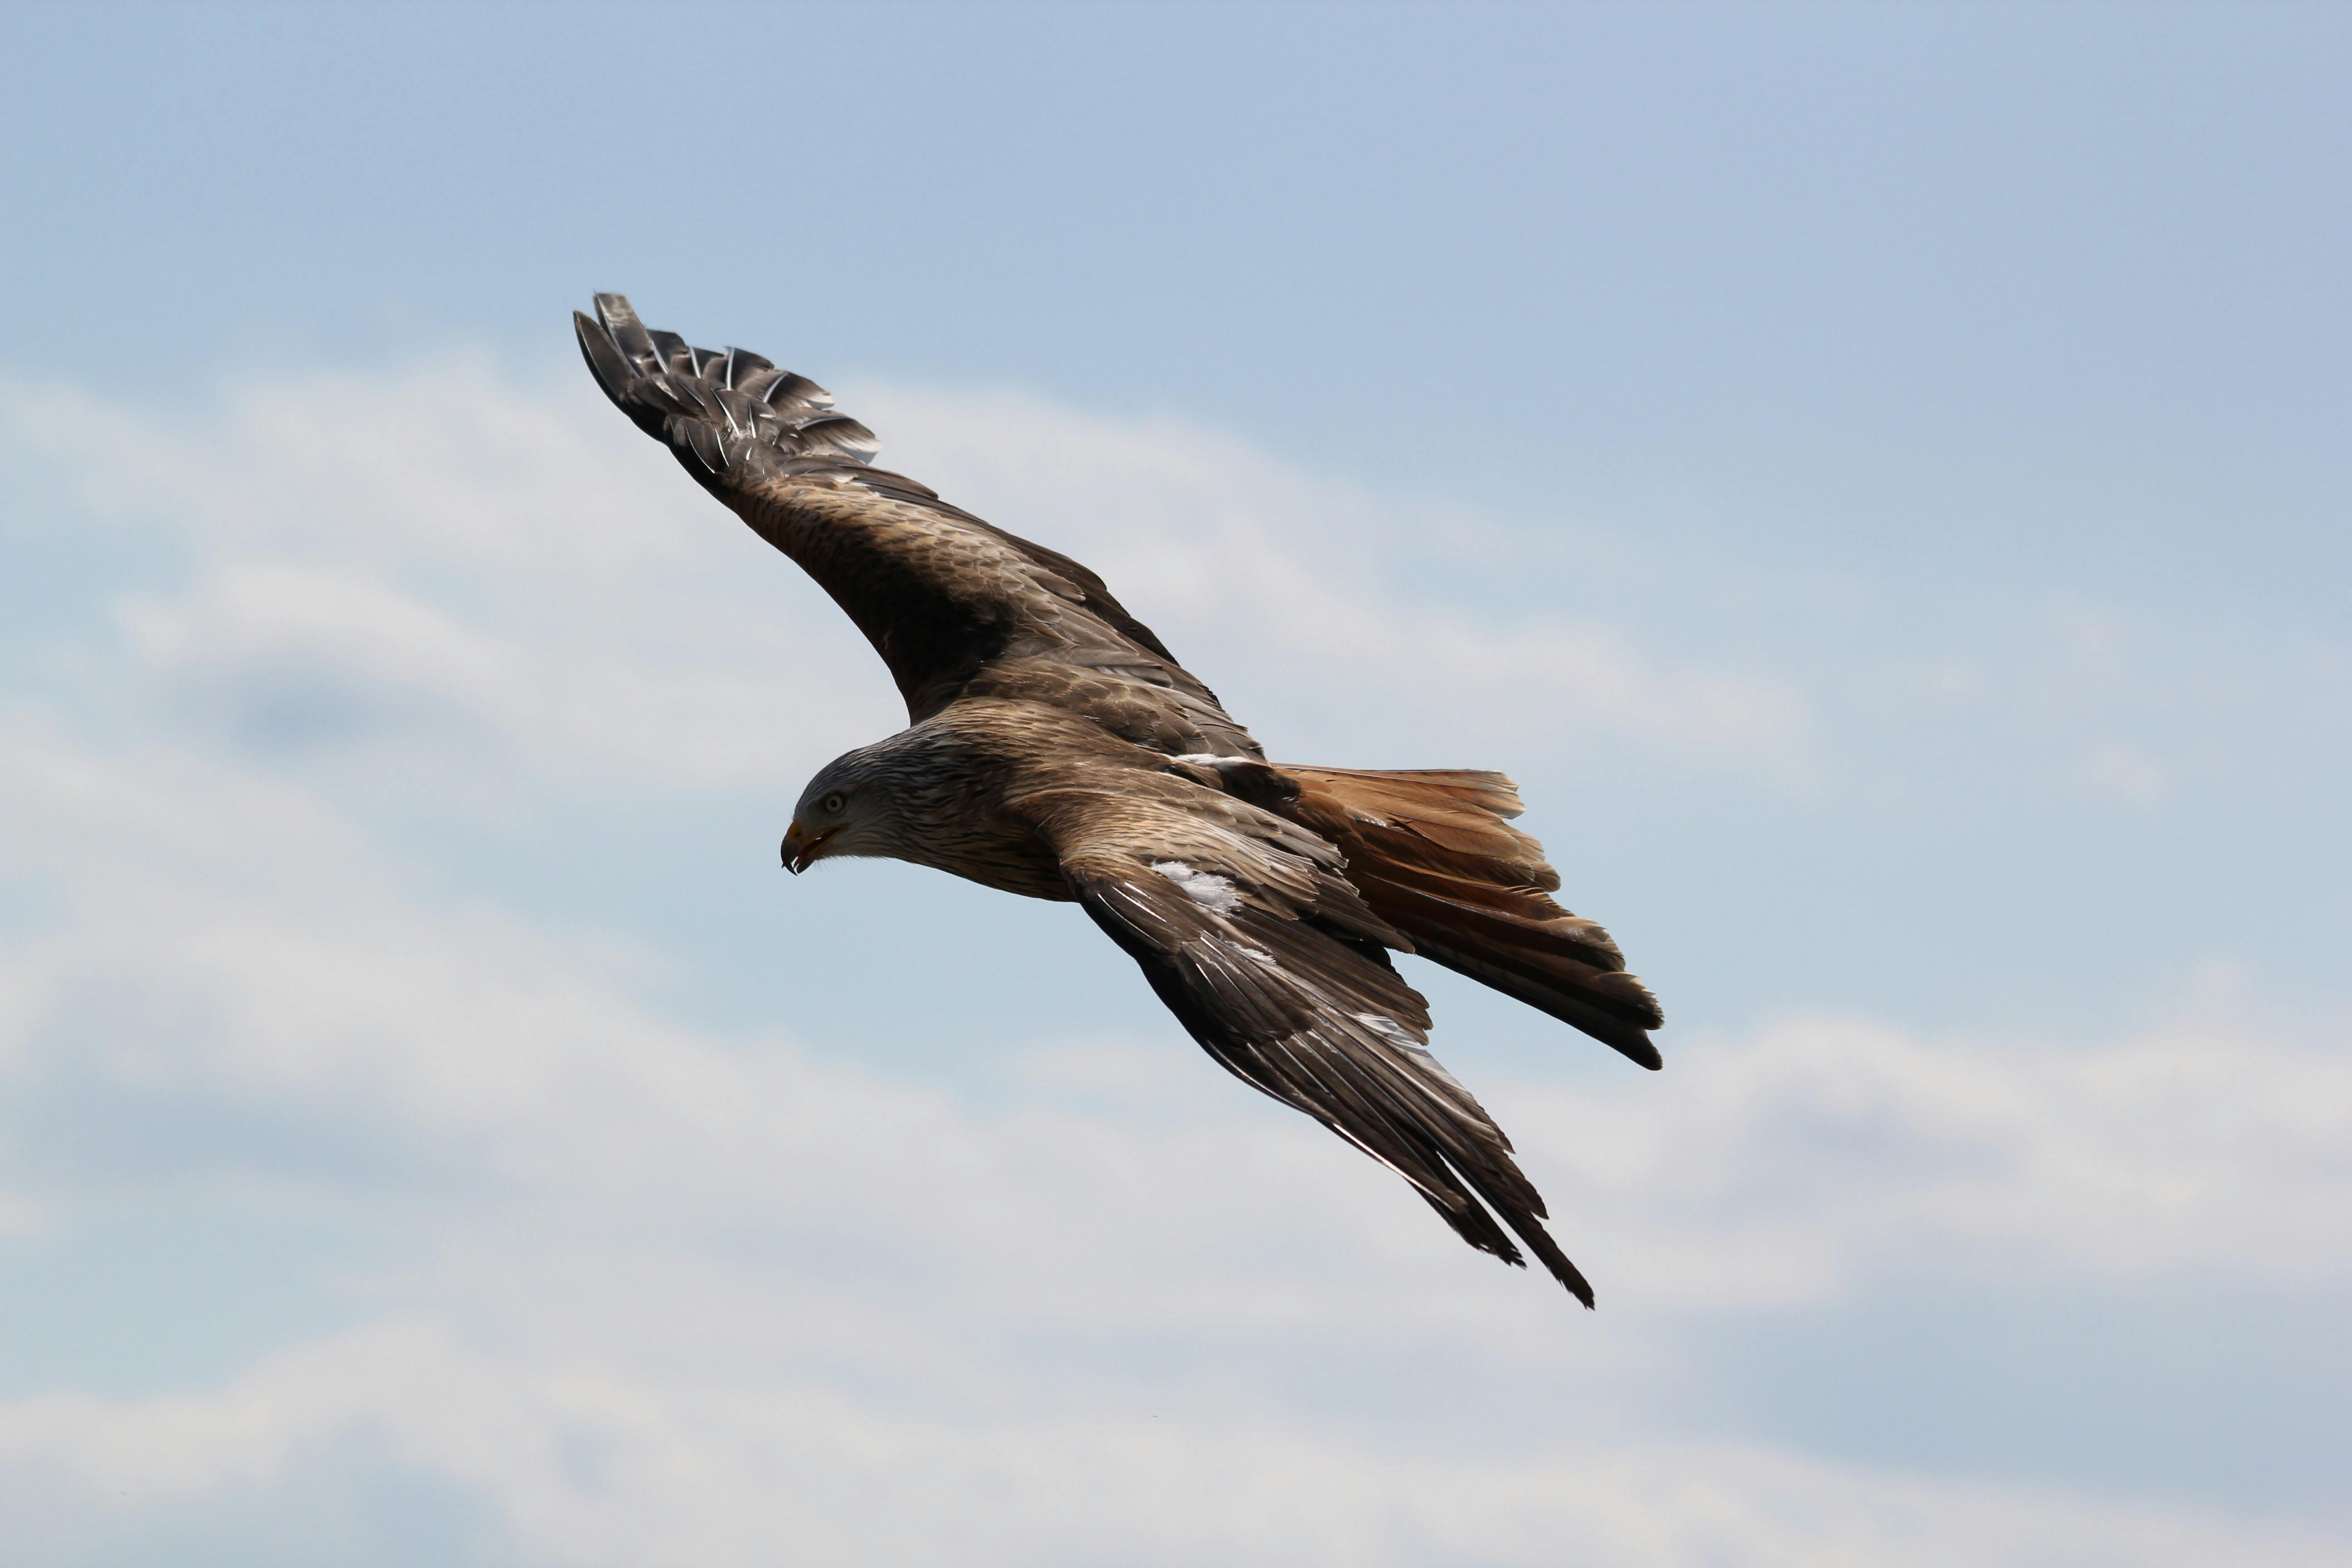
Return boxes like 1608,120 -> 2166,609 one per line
574,294 -> 1661,1307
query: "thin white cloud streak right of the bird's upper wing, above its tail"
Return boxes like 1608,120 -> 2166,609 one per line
858,388 -> 1811,776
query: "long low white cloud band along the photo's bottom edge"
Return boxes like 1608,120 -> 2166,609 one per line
0,1323 -> 2336,1568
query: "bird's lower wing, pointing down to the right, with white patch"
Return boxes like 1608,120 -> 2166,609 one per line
1007,776 -> 1592,1307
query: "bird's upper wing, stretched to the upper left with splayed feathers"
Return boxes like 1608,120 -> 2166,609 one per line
572,294 -> 1258,757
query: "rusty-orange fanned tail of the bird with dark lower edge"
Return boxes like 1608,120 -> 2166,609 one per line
1279,764 -> 1665,1067
